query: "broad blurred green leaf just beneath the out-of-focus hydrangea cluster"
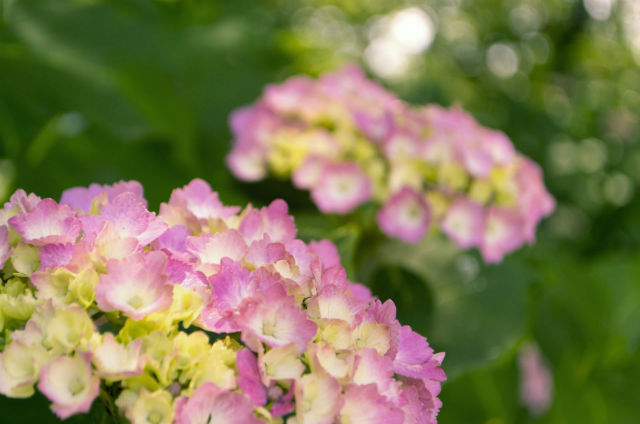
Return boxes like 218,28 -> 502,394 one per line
366,237 -> 535,379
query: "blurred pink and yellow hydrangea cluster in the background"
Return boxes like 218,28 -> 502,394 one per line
227,66 -> 555,262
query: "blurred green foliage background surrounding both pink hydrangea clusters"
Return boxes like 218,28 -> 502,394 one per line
0,0 -> 640,424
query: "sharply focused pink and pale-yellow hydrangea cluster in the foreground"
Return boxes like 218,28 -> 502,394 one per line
0,179 -> 445,424
